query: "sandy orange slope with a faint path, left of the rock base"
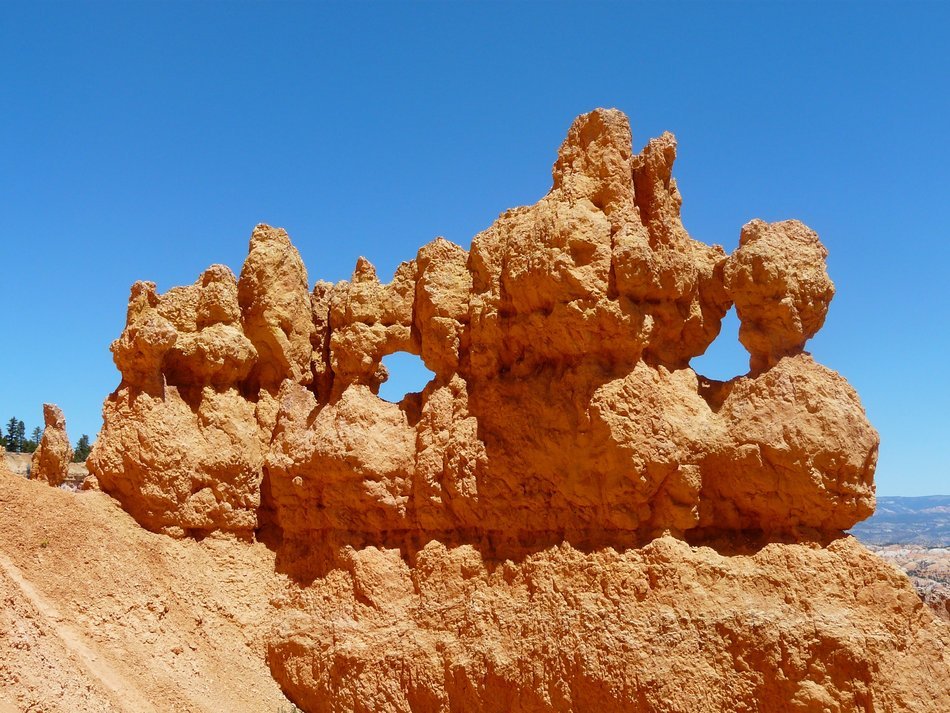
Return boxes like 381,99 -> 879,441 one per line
0,471 -> 293,713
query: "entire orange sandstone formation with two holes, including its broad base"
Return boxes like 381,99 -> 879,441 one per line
88,110 -> 950,713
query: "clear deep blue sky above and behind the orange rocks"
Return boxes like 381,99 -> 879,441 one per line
0,2 -> 950,495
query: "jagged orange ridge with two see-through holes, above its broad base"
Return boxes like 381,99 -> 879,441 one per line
91,111 -> 877,538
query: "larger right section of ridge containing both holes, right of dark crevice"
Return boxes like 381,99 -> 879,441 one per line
258,111 -> 877,540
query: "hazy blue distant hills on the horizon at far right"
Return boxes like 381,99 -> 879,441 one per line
851,495 -> 950,547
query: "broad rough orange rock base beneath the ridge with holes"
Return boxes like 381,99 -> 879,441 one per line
268,537 -> 950,713
